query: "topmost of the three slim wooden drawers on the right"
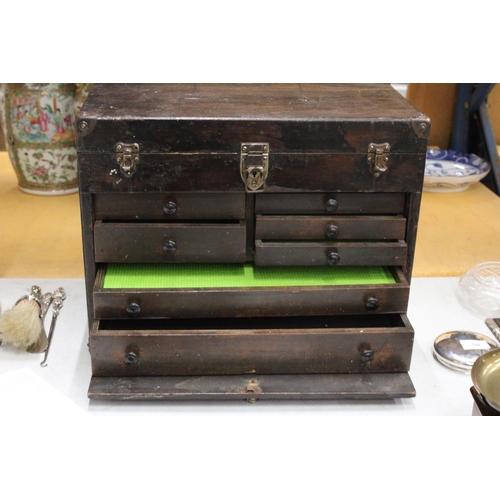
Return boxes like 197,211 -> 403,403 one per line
255,193 -> 405,215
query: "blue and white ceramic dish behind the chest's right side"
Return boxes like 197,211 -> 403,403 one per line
424,148 -> 491,193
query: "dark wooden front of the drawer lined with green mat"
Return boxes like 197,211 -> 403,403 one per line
93,269 -> 409,318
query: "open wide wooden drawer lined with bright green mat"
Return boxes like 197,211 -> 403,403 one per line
93,264 -> 410,319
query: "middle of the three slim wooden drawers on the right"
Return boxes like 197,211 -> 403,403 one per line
255,215 -> 406,240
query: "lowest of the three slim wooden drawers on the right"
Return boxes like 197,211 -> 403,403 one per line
255,240 -> 408,266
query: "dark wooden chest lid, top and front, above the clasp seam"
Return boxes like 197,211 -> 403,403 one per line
77,84 -> 430,154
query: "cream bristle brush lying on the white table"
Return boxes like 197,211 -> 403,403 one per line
0,286 -> 52,352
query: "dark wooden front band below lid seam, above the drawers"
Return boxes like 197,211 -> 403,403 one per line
79,151 -> 425,193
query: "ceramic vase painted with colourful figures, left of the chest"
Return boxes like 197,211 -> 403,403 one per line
2,83 -> 78,195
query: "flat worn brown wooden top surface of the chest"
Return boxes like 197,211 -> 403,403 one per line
77,83 -> 421,125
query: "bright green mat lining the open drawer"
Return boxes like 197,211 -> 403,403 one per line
103,264 -> 396,288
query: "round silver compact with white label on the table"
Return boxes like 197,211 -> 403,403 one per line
434,331 -> 499,373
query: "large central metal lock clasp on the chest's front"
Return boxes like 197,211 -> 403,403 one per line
240,142 -> 269,193
